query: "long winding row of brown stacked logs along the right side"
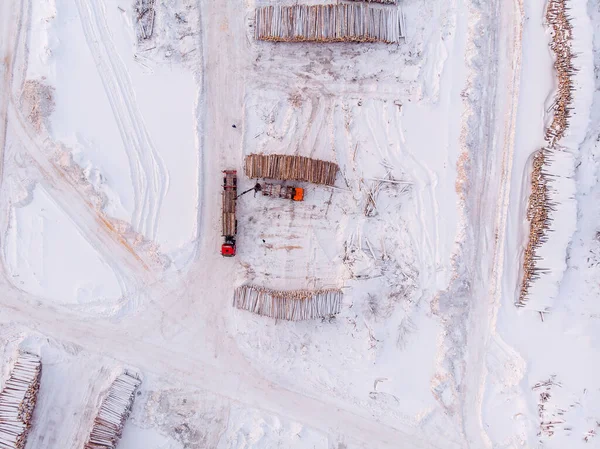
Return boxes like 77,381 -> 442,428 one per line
516,0 -> 576,306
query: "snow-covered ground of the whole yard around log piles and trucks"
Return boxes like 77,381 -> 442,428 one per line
0,0 -> 600,449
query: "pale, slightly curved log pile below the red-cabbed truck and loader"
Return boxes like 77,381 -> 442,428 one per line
233,285 -> 342,321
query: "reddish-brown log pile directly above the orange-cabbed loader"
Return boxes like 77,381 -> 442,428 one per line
245,154 -> 338,186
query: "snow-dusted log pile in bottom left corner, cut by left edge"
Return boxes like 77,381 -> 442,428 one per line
0,352 -> 42,449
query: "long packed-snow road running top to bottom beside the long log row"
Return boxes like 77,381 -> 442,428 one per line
446,0 -> 523,449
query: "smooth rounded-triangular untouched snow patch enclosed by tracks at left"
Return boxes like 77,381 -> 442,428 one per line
4,185 -> 123,304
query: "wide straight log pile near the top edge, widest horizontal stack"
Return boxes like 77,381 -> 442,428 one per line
254,4 -> 404,44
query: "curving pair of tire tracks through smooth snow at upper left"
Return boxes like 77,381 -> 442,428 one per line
76,0 -> 169,240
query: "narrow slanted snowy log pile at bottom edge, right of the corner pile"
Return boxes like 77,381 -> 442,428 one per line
84,373 -> 141,449
